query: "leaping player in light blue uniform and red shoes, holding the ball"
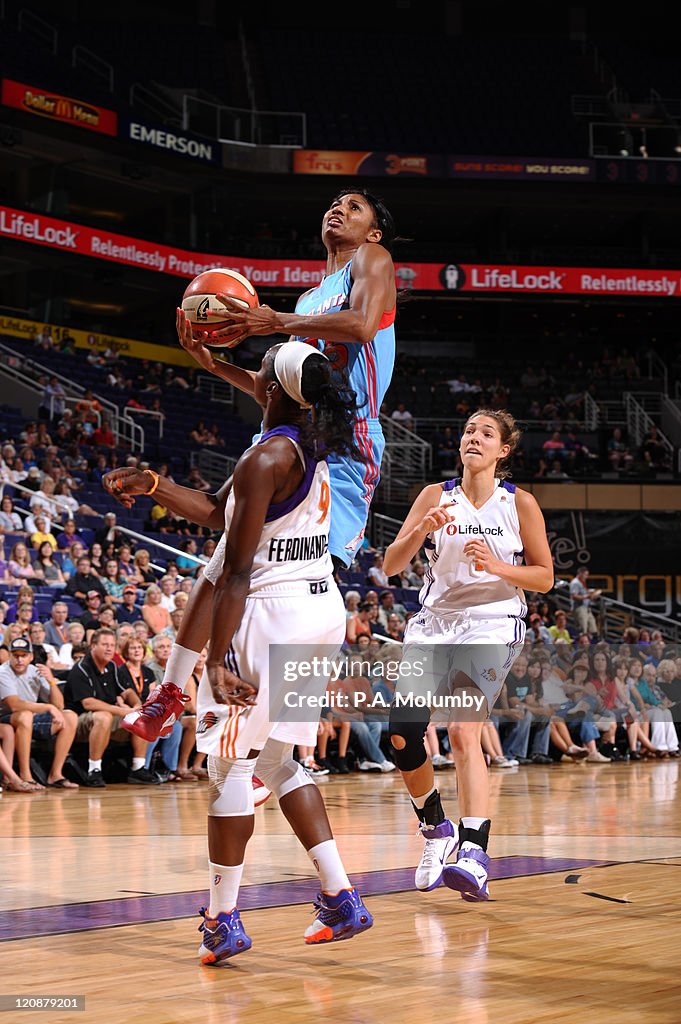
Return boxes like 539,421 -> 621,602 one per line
102,188 -> 396,741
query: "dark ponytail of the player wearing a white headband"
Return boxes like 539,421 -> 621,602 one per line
300,352 -> 367,463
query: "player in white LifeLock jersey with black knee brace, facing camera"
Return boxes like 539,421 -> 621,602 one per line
383,410 -> 553,901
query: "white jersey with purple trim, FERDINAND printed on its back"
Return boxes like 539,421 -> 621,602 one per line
204,426 -> 333,596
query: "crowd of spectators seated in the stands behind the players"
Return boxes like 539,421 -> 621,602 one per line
0,344 -> 681,792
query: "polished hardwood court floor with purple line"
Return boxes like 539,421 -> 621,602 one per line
0,761 -> 681,1024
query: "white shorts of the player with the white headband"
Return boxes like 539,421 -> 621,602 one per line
197,578 -> 345,758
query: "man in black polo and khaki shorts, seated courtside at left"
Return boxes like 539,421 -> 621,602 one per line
63,629 -> 158,788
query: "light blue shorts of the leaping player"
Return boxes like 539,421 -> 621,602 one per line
329,420 -> 385,566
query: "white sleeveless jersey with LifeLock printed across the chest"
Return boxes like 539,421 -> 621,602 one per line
419,479 -> 527,618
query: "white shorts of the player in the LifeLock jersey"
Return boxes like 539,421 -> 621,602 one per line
397,608 -> 525,721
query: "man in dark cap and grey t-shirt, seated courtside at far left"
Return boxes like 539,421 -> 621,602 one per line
0,637 -> 78,790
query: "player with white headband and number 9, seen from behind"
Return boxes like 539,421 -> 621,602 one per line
108,342 -> 373,965
